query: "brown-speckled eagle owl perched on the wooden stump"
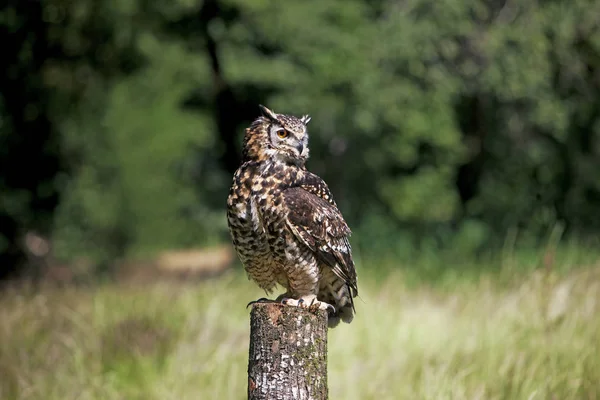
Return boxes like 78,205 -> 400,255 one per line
227,105 -> 358,328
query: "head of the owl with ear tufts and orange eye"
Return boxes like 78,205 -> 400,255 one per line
244,105 -> 310,164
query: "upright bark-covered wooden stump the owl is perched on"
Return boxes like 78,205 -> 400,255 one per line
248,303 -> 328,400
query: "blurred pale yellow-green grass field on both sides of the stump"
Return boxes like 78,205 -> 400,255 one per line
0,253 -> 600,400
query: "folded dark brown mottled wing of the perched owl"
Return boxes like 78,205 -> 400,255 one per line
283,174 -> 358,296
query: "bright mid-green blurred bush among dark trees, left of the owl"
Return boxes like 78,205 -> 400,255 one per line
51,34 -> 225,260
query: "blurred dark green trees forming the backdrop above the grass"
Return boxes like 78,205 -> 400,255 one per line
0,0 -> 600,266
